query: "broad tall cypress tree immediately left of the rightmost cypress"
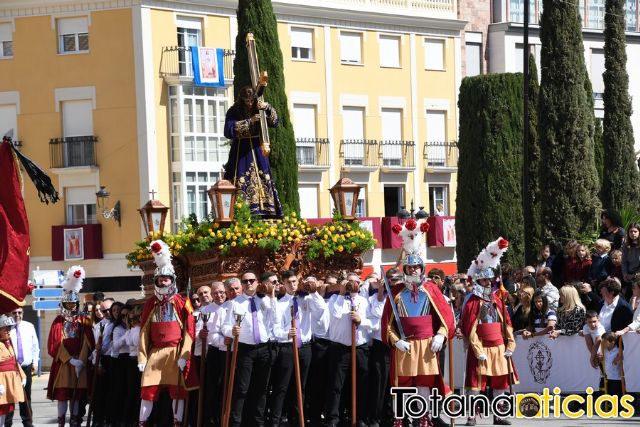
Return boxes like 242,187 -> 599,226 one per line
538,0 -> 600,239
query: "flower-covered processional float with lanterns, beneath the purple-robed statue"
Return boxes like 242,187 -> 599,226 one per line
127,178 -> 376,297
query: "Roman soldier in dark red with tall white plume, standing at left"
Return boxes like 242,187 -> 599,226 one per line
47,266 -> 95,427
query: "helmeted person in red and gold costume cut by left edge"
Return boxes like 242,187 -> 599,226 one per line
0,314 -> 27,426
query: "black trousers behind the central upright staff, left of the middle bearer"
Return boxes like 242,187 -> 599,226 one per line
269,343 -> 311,427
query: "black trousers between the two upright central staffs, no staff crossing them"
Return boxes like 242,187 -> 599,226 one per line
305,338 -> 331,425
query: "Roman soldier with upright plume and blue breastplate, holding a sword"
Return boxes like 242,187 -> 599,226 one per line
381,218 -> 455,427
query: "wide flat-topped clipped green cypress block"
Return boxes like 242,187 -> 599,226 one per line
456,74 -> 524,271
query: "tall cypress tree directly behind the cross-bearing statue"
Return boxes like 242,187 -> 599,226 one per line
233,0 -> 300,212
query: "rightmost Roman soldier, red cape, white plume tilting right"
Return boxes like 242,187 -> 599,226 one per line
461,238 -> 518,426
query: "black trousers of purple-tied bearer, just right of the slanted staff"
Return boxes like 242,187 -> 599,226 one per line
229,343 -> 273,427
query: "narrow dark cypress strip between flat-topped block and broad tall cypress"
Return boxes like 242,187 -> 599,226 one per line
524,54 -> 544,264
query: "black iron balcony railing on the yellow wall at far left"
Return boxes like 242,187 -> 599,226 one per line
49,135 -> 98,168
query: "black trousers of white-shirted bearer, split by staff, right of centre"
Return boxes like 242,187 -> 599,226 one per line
325,342 -> 369,424
